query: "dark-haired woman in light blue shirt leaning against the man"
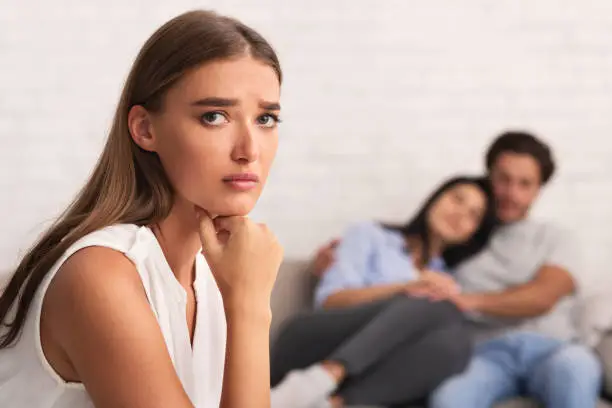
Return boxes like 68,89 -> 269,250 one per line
271,177 -> 494,408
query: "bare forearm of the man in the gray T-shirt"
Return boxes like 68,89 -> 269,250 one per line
462,265 -> 576,318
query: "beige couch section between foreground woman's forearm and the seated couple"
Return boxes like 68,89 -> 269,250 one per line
270,260 -> 317,343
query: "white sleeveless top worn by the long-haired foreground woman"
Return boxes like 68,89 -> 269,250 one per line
0,224 -> 226,408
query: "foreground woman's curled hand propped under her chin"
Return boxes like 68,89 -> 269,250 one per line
197,210 -> 283,310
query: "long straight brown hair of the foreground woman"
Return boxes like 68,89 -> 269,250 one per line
0,11 -> 282,349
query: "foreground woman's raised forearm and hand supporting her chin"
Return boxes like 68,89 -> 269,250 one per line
200,213 -> 283,408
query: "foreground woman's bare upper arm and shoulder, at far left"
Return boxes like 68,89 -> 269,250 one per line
41,247 -> 195,408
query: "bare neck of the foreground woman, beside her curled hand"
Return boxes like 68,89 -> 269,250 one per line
151,198 -> 202,289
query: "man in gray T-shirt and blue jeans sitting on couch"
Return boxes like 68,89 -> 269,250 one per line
315,132 -> 602,408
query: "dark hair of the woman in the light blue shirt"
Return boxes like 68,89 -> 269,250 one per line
383,176 -> 496,268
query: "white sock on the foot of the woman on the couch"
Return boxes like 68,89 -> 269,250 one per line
272,364 -> 338,408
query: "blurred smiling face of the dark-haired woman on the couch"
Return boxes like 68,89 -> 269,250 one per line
427,183 -> 487,244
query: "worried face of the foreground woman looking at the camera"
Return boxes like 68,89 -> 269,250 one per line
139,56 -> 280,216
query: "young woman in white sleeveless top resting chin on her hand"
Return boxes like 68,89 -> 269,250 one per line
0,11 -> 282,408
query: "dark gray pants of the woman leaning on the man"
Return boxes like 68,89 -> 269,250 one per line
270,296 -> 471,405
